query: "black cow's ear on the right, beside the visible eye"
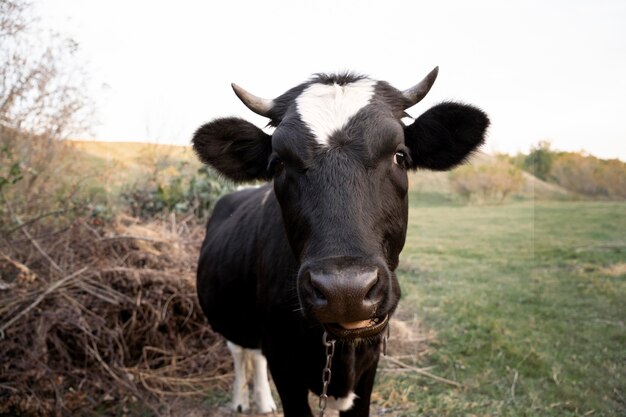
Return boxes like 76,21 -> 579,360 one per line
404,103 -> 489,171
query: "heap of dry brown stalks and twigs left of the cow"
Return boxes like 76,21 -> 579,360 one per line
0,217 -> 230,416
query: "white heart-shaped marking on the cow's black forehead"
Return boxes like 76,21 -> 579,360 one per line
296,79 -> 376,146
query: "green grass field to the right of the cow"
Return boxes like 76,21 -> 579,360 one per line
377,195 -> 626,416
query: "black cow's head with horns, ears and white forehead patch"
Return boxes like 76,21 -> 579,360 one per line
193,68 -> 489,338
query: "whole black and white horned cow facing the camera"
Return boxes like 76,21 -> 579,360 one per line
192,67 -> 489,417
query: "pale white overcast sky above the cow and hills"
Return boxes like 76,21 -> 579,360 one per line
35,0 -> 626,161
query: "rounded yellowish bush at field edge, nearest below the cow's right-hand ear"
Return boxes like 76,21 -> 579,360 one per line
450,158 -> 523,202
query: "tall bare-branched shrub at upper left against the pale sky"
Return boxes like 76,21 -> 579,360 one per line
0,0 -> 91,229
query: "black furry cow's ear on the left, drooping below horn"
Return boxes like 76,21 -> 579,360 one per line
192,117 -> 272,182
